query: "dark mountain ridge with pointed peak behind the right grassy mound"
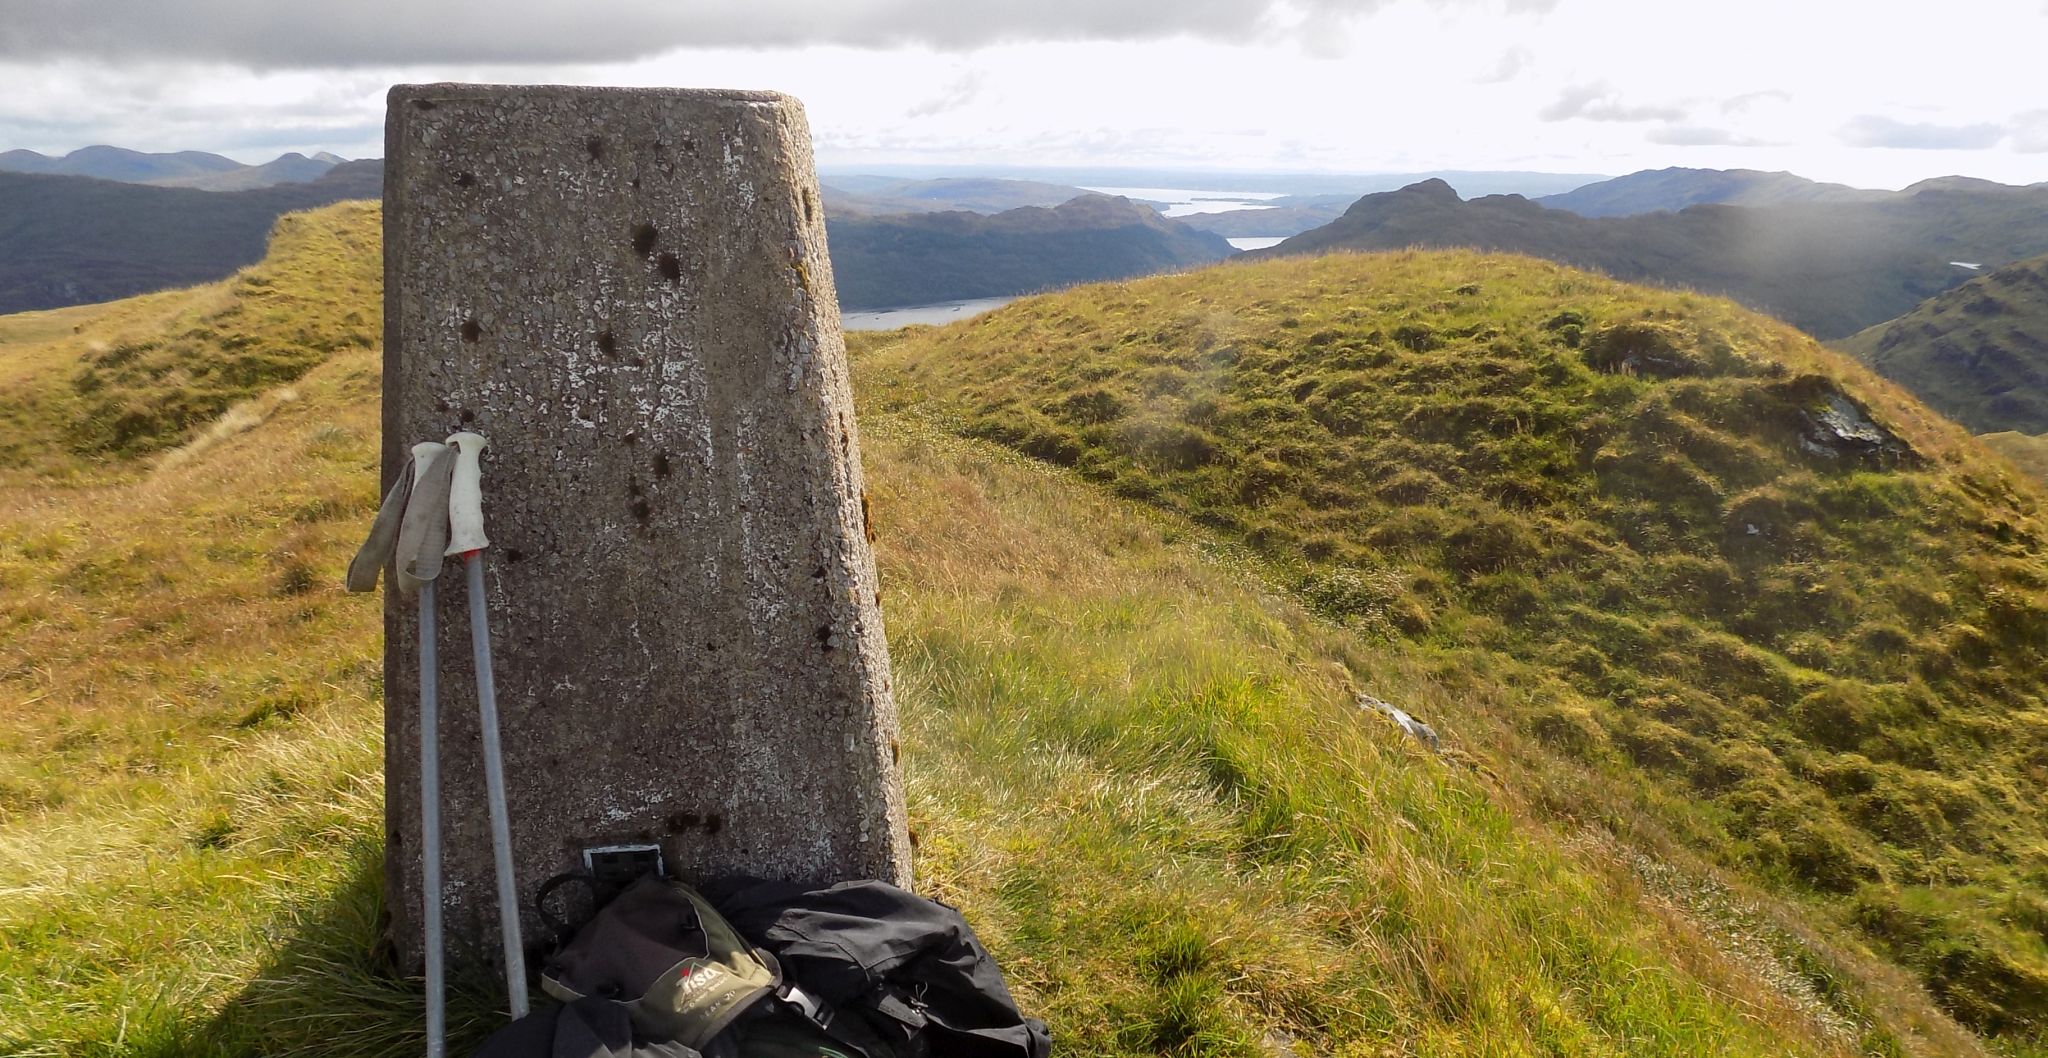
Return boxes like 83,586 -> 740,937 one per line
1251,178 -> 2048,338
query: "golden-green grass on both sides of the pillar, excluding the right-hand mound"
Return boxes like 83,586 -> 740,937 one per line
0,207 -> 1982,1058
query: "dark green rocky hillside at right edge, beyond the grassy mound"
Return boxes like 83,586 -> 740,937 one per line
1839,256 -> 2048,434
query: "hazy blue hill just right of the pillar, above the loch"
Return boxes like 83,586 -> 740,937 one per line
829,194 -> 1231,309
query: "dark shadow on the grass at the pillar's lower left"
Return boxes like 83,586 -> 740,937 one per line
138,843 -> 506,1058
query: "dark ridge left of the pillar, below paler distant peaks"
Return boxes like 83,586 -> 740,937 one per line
0,151 -> 383,313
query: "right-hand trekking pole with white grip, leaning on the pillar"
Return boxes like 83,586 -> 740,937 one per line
446,432 -> 526,1019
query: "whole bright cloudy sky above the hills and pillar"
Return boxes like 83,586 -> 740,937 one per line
0,0 -> 2048,186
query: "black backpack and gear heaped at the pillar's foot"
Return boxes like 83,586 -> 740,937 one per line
477,876 -> 1051,1058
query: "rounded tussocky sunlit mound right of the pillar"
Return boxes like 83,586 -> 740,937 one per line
862,252 -> 2048,1046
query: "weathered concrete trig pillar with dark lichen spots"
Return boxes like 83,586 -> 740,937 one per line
383,84 -> 909,968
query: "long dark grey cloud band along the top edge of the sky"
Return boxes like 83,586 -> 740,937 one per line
0,0 -> 1433,70
